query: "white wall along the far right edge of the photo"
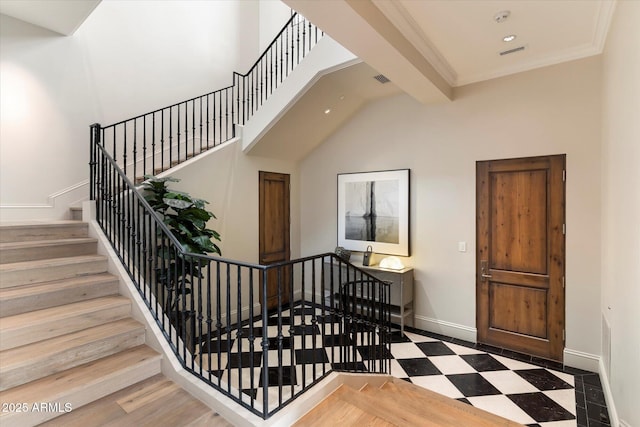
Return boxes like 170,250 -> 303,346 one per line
602,1 -> 640,426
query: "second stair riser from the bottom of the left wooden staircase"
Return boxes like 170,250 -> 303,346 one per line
0,326 -> 145,391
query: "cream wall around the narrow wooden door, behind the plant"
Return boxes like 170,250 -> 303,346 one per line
160,140 -> 300,323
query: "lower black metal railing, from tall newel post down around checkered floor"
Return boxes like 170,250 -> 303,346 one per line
91,140 -> 391,419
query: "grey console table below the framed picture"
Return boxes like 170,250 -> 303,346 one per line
324,264 -> 414,332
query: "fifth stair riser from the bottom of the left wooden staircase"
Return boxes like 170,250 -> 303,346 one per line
0,258 -> 107,289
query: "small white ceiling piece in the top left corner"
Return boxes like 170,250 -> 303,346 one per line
0,0 -> 101,36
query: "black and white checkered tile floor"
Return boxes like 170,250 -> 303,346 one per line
195,308 -> 607,427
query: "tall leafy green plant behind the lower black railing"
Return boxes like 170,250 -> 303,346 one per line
142,175 -> 222,351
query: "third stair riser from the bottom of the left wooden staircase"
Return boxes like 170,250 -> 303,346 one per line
0,302 -> 131,351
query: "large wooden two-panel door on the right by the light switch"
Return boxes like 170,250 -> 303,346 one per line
476,155 -> 565,361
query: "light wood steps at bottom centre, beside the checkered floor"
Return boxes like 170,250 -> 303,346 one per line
294,377 -> 523,427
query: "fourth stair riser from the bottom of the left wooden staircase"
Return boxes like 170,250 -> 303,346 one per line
0,278 -> 118,317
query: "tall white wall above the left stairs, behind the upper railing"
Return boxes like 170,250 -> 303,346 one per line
0,0 -> 259,224
